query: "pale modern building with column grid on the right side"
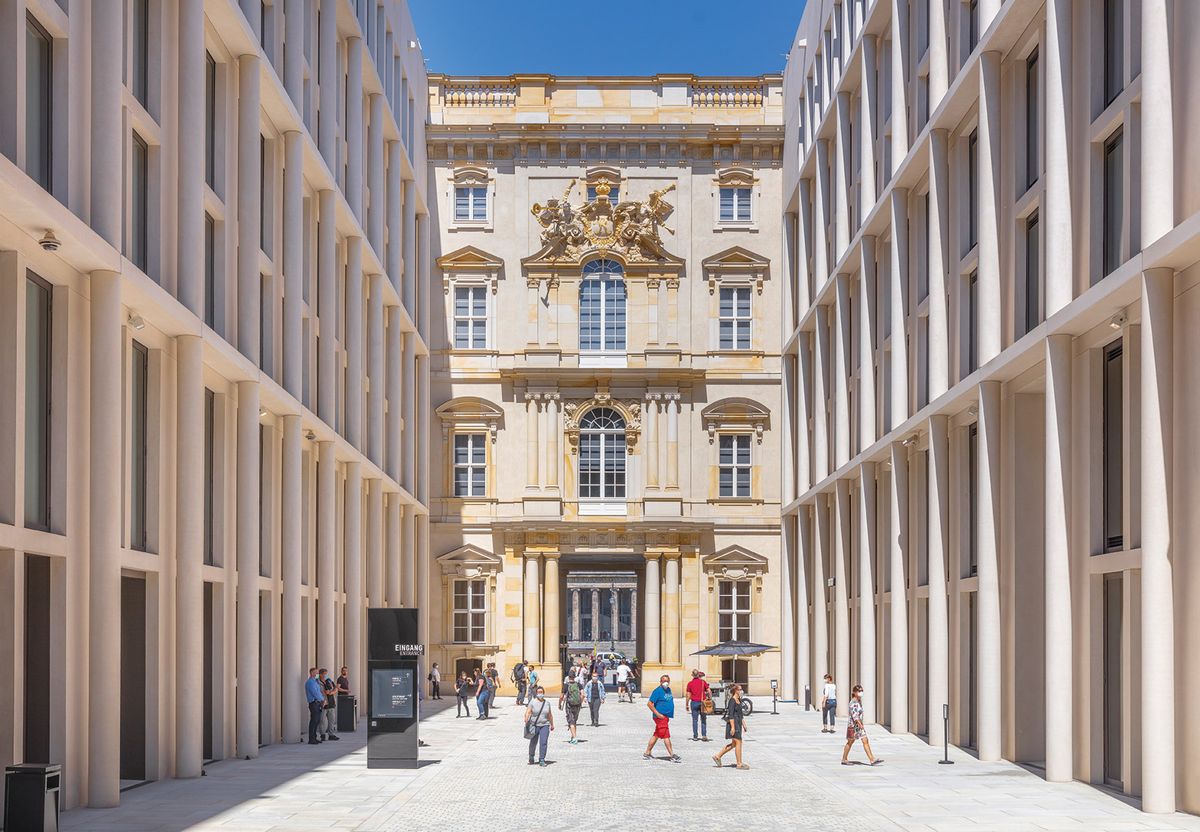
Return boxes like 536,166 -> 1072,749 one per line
780,0 -> 1200,812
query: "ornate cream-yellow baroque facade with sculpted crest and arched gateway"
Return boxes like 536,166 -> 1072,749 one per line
428,74 -> 788,690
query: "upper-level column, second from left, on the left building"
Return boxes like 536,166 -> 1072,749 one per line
175,0 -> 205,314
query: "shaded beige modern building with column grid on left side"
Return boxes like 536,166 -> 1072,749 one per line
0,0 -> 431,807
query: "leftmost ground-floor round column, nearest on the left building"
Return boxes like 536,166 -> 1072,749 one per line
86,272 -> 124,807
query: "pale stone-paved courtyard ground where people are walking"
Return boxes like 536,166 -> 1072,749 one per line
64,698 -> 1200,832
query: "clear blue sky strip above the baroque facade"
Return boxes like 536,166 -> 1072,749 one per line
409,0 -> 804,76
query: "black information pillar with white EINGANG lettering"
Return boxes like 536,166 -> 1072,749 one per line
367,607 -> 425,768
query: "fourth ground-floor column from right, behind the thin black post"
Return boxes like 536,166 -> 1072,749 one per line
925,414 -> 950,747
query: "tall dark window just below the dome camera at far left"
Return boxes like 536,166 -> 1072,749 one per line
25,271 -> 52,531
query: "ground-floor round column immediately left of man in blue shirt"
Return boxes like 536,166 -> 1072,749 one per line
280,414 -> 302,742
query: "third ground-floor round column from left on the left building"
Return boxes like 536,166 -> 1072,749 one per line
235,382 -> 263,758
